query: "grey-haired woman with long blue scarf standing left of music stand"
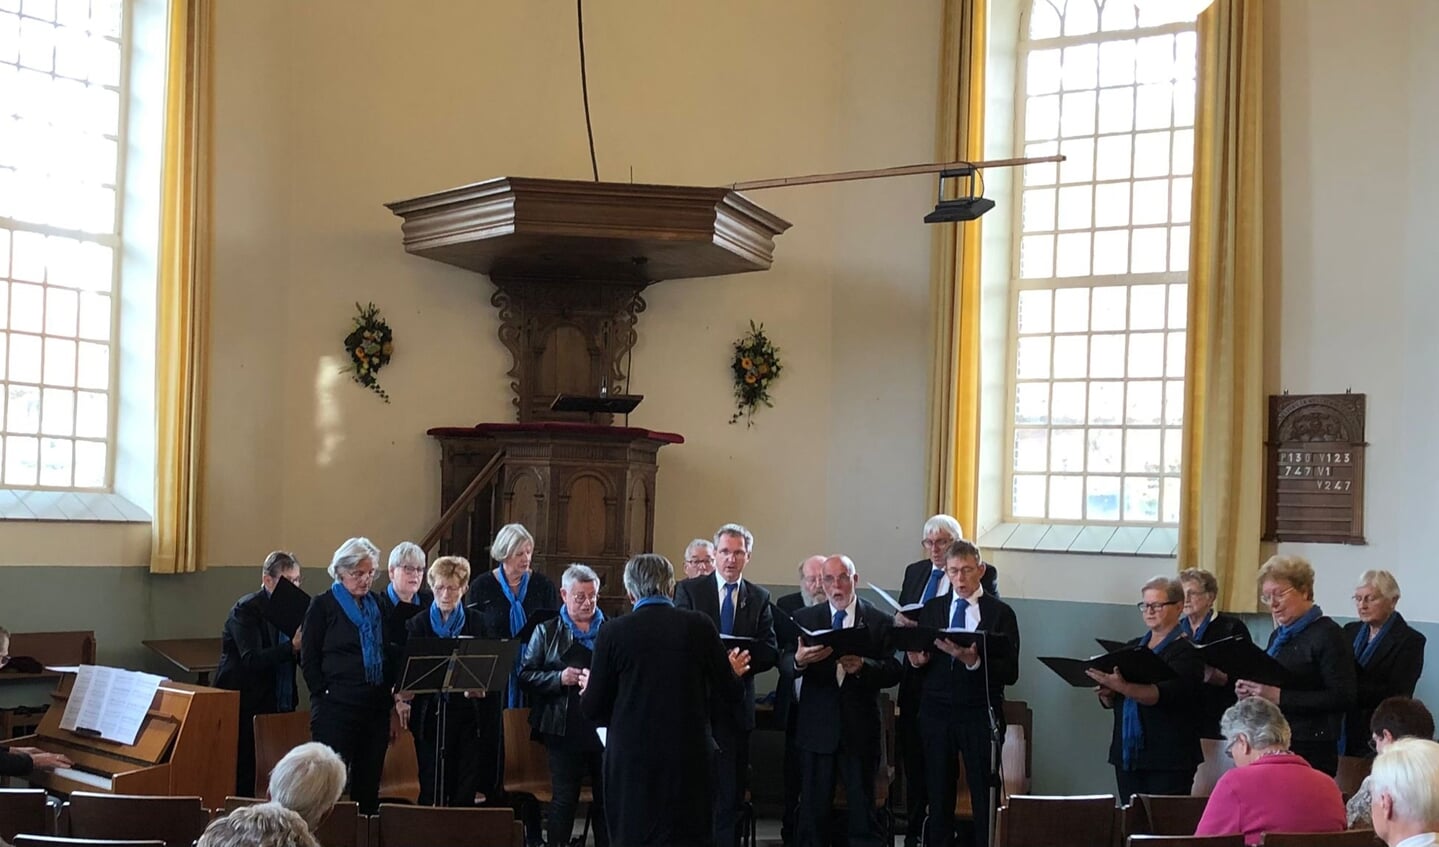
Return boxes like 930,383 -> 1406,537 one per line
299,538 -> 396,814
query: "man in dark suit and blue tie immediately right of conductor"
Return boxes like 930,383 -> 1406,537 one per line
675,523 -> 780,847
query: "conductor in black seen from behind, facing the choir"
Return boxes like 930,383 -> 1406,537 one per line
580,554 -> 743,847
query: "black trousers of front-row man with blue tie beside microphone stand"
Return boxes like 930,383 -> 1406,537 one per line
920,706 -> 994,847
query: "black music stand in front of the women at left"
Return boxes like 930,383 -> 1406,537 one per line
399,636 -> 521,805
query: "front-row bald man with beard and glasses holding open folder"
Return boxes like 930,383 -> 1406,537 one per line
780,557 -> 899,847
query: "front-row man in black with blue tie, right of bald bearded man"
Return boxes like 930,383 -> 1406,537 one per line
905,539 -> 1019,847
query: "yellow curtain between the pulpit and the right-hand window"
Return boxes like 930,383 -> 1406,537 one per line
928,0 -> 989,538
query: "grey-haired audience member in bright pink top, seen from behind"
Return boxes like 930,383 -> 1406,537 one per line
1194,697 -> 1344,847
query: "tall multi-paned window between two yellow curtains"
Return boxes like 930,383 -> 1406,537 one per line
1004,0 -> 1196,526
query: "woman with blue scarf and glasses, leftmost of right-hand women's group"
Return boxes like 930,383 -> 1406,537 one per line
1089,577 -> 1204,802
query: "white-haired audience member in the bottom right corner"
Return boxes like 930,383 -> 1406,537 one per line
1368,738 -> 1439,847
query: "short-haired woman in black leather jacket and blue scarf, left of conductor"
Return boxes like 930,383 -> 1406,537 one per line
519,565 -> 610,847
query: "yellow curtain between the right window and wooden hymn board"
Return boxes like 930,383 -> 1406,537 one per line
1179,0 -> 1266,611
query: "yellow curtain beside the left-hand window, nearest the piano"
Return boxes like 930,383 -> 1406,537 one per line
150,0 -> 213,574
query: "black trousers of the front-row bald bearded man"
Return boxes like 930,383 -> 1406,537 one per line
799,751 -> 879,847
